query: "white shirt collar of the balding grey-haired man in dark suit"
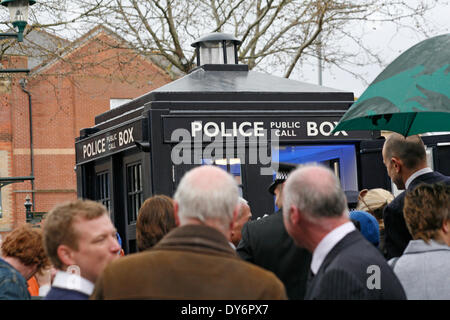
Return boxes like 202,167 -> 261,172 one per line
311,221 -> 356,274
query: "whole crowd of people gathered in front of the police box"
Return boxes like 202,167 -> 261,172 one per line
0,133 -> 450,300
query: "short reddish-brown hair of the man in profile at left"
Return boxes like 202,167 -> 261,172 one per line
44,199 -> 108,269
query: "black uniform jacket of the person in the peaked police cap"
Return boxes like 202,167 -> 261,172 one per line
236,210 -> 311,299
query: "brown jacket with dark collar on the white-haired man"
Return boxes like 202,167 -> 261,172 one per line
91,225 -> 286,300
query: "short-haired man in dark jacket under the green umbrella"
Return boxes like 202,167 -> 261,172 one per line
382,133 -> 450,259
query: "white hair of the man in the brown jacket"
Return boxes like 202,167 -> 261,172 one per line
174,165 -> 239,225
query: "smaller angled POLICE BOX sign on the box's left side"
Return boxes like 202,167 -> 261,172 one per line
75,120 -> 142,164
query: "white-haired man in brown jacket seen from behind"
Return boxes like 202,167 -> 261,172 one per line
92,166 -> 286,300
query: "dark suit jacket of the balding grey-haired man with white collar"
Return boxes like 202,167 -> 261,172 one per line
305,230 -> 406,300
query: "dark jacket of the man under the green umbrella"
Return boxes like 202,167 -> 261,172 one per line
383,172 -> 450,260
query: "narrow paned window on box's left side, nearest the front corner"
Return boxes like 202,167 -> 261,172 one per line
127,163 -> 143,223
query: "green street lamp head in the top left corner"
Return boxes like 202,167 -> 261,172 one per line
0,0 -> 36,42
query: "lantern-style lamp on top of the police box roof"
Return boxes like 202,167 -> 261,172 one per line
191,32 -> 242,67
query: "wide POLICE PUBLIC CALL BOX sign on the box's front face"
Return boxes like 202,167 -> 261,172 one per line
163,115 -> 372,143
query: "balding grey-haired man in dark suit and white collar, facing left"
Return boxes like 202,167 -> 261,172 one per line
283,165 -> 406,300
